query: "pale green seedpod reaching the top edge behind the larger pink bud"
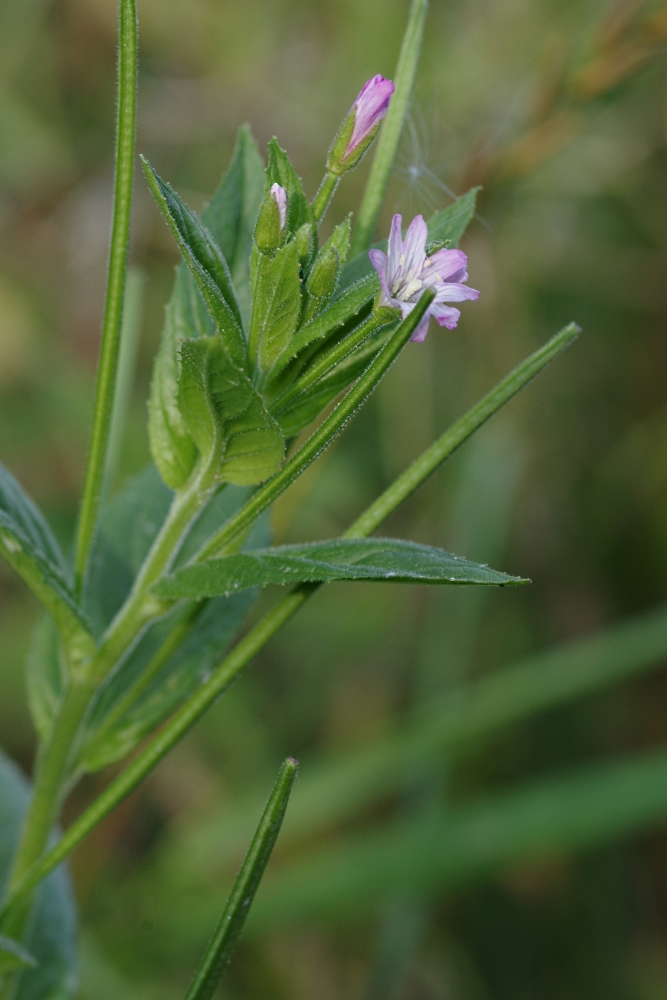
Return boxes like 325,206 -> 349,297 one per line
350,0 -> 428,257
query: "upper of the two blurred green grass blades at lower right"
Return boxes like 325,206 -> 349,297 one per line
160,596 -> 667,881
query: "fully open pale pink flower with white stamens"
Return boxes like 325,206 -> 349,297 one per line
369,215 -> 479,343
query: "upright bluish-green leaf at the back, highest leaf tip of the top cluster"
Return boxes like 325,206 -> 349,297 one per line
201,125 -> 265,322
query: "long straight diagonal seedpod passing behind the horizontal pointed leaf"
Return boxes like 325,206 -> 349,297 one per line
0,324 -> 579,927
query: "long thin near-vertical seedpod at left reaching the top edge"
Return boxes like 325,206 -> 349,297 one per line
75,0 -> 137,596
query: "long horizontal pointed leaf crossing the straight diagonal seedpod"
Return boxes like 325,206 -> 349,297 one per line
155,538 -> 528,599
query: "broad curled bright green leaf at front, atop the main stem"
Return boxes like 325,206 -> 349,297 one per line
178,337 -> 285,486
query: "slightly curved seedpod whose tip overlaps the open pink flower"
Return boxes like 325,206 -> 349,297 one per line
196,289 -> 434,561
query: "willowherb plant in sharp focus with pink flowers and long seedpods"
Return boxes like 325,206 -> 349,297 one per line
0,0 -> 577,1000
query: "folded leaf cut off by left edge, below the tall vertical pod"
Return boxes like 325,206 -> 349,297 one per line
0,464 -> 94,658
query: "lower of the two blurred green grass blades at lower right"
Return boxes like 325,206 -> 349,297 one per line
251,748 -> 667,929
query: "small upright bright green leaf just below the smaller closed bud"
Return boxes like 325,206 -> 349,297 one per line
250,240 -> 301,374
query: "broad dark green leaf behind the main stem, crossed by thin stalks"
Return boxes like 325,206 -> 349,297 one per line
72,466 -> 271,771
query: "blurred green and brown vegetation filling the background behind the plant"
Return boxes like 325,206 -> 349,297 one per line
0,0 -> 667,1000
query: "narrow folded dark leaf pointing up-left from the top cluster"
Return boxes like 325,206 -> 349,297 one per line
142,158 -> 246,368
